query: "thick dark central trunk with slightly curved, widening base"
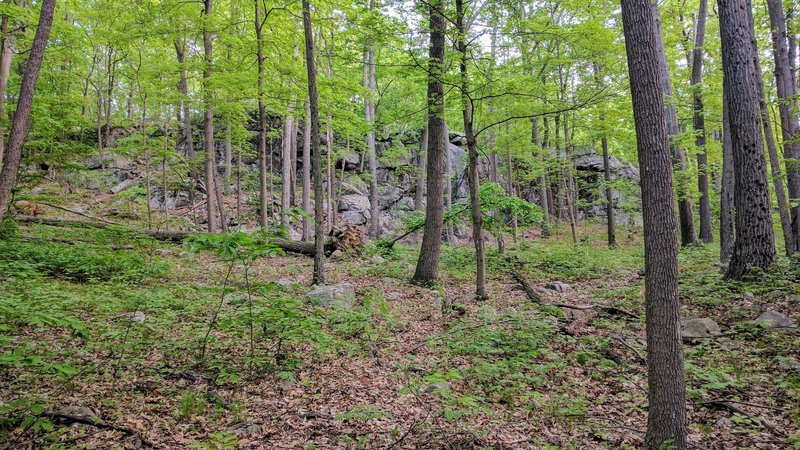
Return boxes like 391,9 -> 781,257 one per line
412,0 -> 447,284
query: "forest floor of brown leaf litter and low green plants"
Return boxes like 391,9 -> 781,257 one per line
0,196 -> 800,449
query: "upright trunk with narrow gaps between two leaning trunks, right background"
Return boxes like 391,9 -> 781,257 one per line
691,0 -> 714,243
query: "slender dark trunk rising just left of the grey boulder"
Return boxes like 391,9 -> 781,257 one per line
303,0 -> 325,284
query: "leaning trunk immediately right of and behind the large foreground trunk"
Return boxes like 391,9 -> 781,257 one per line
652,3 -> 697,246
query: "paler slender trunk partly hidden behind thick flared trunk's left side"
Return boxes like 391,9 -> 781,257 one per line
719,89 -> 735,266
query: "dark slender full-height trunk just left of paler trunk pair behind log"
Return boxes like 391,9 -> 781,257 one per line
254,0 -> 272,229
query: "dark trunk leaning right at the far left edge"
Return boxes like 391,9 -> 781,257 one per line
0,0 -> 56,222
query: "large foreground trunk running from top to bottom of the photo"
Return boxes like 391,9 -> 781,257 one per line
622,0 -> 687,450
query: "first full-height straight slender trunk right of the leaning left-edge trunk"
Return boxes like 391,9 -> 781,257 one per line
203,0 -> 216,233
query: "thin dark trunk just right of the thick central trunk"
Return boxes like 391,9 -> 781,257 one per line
456,0 -> 488,300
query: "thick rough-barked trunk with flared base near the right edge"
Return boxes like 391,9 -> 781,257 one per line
718,0 -> 775,279
